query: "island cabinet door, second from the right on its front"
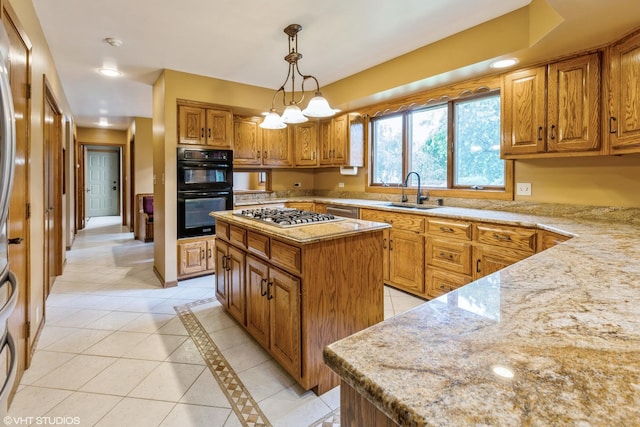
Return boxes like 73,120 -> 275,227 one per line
247,255 -> 270,349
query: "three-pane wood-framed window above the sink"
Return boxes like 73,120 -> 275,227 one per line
369,90 -> 512,196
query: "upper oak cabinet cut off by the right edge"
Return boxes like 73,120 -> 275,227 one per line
607,33 -> 640,154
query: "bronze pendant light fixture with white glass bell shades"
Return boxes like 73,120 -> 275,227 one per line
260,24 -> 336,129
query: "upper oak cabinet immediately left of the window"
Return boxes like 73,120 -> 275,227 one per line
319,114 -> 364,166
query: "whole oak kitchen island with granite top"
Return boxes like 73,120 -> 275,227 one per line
211,211 -> 389,394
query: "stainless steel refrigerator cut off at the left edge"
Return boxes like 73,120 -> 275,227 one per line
0,22 -> 18,414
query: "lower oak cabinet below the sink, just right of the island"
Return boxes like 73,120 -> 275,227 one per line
360,209 -> 425,296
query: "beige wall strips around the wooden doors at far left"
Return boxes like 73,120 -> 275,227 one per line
4,0 -> 74,348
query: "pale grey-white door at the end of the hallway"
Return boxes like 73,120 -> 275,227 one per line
86,149 -> 120,217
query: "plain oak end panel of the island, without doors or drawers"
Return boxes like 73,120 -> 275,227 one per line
301,230 -> 384,394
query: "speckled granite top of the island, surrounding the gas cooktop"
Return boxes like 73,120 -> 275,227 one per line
210,210 -> 390,244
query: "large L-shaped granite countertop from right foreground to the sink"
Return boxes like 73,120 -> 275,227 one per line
315,202 -> 640,426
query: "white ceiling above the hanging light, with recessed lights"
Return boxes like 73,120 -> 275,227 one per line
32,0 -> 640,129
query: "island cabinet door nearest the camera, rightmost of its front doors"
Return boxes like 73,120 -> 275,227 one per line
267,268 -> 301,378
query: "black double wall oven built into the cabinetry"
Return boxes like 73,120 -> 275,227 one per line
177,147 -> 233,239
